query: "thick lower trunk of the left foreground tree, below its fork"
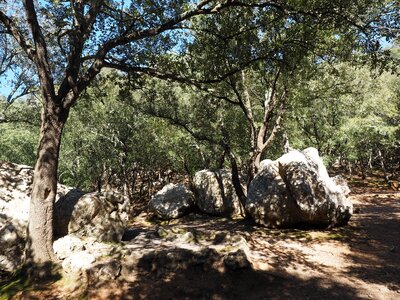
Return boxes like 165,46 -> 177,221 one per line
27,101 -> 68,264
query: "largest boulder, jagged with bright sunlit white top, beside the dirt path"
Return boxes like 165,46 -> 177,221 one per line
246,148 -> 353,227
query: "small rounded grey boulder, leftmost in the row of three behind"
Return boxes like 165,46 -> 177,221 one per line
148,183 -> 195,220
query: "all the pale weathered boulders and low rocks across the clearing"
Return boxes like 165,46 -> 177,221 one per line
0,148 -> 353,280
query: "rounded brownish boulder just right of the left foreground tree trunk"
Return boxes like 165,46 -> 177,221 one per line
54,190 -> 128,242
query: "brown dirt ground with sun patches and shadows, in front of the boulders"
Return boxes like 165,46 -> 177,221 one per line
9,189 -> 400,300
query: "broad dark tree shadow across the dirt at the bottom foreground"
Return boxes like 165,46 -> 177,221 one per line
87,249 -> 357,299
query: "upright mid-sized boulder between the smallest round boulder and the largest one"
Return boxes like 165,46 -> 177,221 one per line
193,170 -> 245,218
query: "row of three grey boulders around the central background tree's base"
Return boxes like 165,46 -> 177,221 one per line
149,148 -> 353,227
